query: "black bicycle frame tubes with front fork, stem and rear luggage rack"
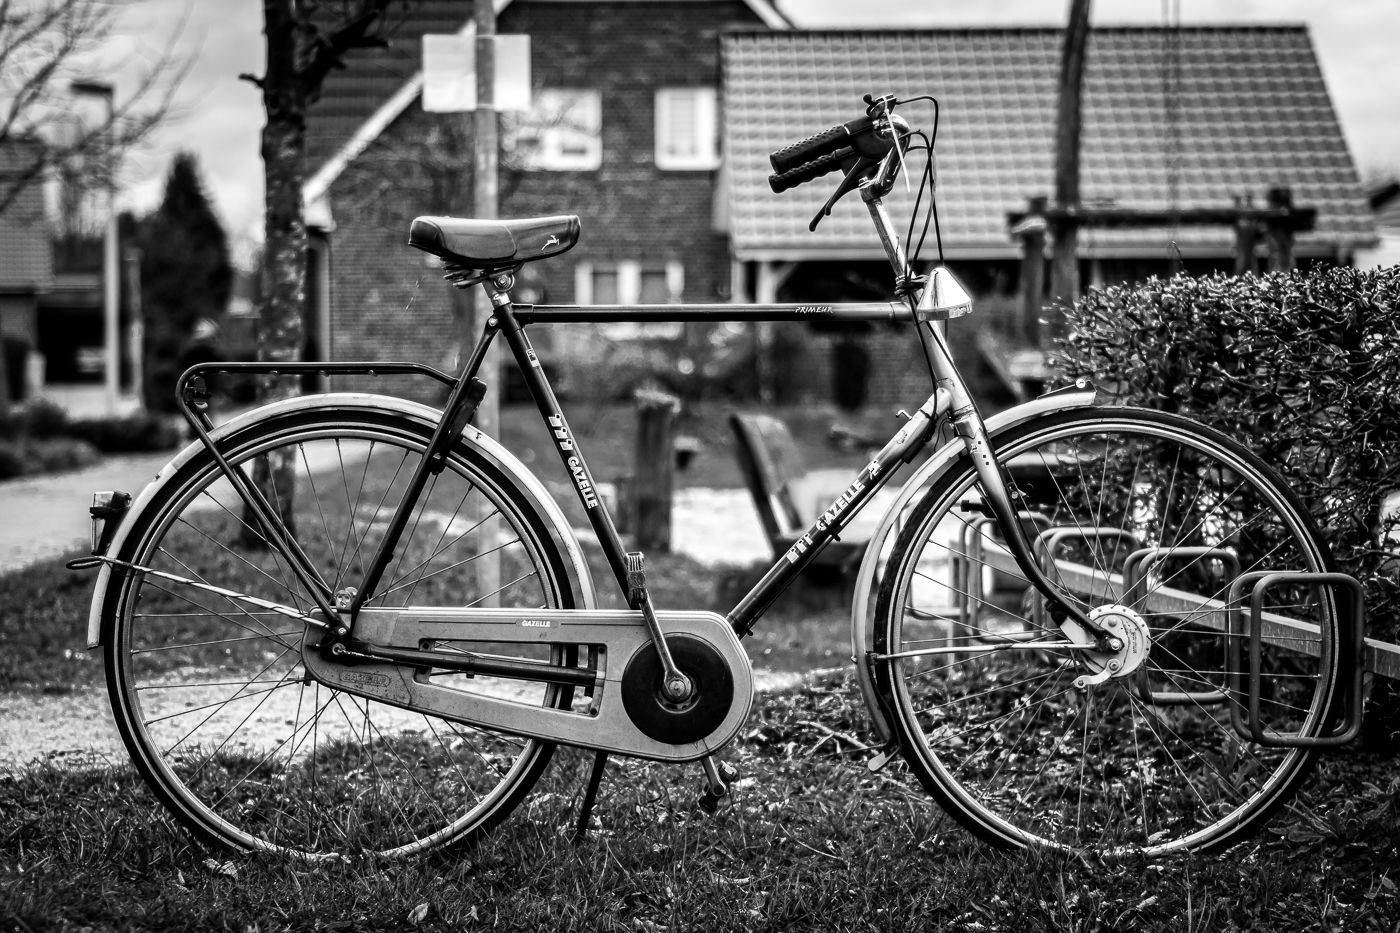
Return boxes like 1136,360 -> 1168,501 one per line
181,149 -> 1103,650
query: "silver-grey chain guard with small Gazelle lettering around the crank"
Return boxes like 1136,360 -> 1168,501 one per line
301,607 -> 753,762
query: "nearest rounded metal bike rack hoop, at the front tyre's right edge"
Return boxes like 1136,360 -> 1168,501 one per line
1226,570 -> 1366,748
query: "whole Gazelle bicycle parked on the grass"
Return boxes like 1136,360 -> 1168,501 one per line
73,97 -> 1361,859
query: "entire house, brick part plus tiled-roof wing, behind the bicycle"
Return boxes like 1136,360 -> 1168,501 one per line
307,15 -> 1375,405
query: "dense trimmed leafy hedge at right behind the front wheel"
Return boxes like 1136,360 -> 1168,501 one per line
1058,266 -> 1400,652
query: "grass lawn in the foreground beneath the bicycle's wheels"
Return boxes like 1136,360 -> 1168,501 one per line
0,678 -> 1400,932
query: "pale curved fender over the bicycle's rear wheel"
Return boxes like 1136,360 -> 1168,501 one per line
87,392 -> 598,649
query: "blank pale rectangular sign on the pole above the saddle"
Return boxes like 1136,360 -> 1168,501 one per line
423,34 -> 531,113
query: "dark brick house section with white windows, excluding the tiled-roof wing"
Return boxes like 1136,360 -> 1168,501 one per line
307,0 -> 788,392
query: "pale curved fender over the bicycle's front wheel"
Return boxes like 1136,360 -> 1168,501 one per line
851,389 -> 1098,742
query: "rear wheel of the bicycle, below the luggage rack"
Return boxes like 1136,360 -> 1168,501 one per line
102,408 -> 575,859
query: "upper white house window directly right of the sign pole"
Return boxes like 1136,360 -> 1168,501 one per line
503,88 -> 603,172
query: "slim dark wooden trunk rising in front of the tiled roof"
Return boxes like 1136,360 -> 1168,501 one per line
1050,0 -> 1089,329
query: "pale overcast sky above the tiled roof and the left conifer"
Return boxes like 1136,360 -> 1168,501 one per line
109,0 -> 1400,261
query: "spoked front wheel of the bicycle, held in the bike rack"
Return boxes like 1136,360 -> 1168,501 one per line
874,409 -> 1337,856
